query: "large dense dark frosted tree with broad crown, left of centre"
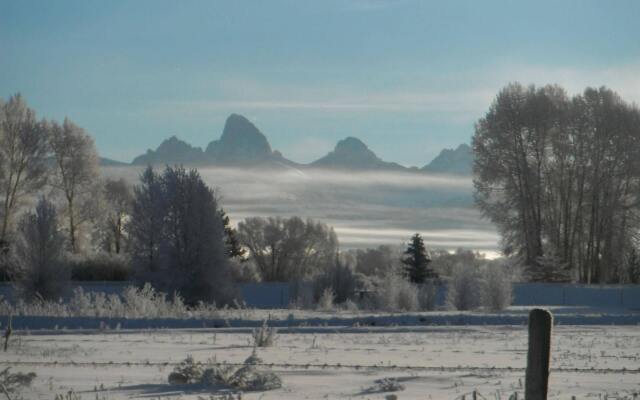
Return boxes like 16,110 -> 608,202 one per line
128,167 -> 235,304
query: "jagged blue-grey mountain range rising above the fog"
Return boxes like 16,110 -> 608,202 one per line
101,114 -> 473,175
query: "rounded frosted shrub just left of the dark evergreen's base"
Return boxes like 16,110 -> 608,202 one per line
375,272 -> 420,311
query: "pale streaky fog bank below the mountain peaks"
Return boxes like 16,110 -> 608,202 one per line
103,167 -> 498,256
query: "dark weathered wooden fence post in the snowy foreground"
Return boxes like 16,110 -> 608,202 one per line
524,308 -> 553,400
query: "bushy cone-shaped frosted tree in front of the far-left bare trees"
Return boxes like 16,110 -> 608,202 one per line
14,197 -> 71,300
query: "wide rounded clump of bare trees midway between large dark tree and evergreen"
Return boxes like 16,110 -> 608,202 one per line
238,217 -> 338,282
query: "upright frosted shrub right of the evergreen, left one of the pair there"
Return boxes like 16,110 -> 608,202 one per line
447,265 -> 482,311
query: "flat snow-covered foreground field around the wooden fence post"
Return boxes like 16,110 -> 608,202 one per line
6,325 -> 640,400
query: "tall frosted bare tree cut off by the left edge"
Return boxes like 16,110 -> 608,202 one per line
0,94 -> 47,248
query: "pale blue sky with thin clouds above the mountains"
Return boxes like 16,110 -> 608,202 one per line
0,0 -> 640,166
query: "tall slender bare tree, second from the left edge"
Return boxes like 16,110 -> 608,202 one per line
49,118 -> 100,253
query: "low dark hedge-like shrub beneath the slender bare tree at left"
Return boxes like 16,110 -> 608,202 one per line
67,253 -> 131,282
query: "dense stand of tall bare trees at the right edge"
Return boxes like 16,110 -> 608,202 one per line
473,83 -> 640,283
